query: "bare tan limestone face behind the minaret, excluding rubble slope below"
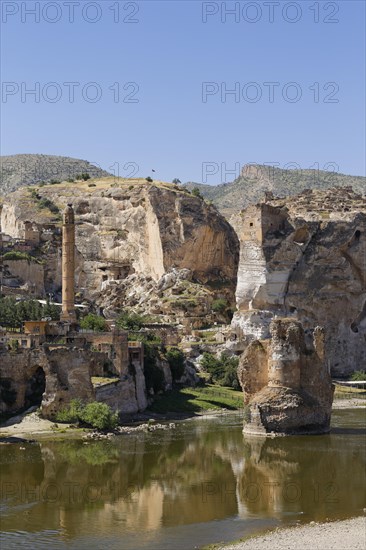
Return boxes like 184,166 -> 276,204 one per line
1,178 -> 239,320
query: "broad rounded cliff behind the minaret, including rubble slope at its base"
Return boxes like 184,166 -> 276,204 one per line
1,178 -> 239,324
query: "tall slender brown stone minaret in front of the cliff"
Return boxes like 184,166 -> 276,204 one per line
61,204 -> 76,323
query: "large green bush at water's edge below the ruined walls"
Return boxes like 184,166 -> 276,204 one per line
56,399 -> 118,430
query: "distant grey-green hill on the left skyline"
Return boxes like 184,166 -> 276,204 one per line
0,155 -> 110,195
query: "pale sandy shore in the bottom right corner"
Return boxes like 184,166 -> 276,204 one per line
218,517 -> 366,550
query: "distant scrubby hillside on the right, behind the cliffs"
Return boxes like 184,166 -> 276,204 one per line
186,164 -> 366,218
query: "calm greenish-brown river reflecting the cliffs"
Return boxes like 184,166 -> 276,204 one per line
0,409 -> 366,550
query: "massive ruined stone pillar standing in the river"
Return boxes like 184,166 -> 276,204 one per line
238,319 -> 334,435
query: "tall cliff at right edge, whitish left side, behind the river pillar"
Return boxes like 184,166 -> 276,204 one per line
232,189 -> 366,376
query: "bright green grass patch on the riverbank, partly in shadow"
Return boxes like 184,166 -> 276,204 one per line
149,384 -> 244,414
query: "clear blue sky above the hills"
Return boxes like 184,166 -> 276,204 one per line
1,0 -> 366,184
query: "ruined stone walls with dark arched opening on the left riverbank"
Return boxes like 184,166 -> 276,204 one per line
0,344 -> 147,419
